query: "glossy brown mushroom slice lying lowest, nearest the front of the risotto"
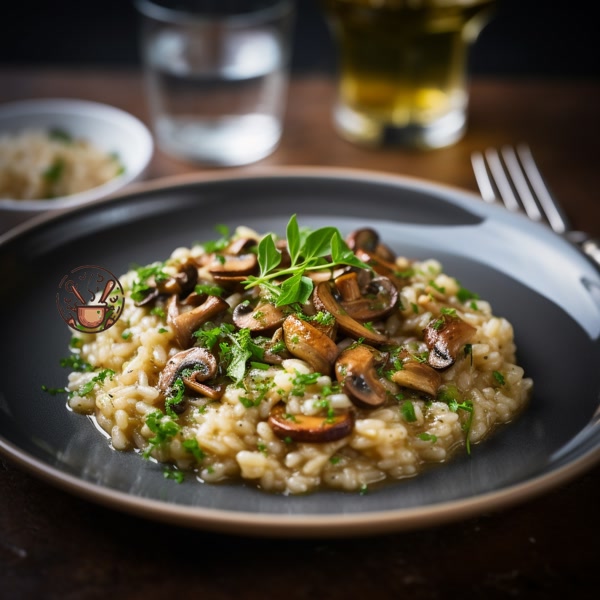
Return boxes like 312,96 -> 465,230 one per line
269,404 -> 354,444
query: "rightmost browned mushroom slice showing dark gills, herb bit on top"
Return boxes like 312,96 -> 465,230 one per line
423,314 -> 476,369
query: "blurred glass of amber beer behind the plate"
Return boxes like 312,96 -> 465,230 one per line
321,0 -> 495,149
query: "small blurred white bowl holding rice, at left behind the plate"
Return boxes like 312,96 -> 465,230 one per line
0,98 -> 154,233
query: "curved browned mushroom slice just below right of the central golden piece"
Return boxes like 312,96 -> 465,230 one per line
335,344 -> 388,408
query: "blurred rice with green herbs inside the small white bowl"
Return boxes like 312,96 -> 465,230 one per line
0,129 -> 124,200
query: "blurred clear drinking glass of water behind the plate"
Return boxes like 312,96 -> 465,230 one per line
136,0 -> 294,166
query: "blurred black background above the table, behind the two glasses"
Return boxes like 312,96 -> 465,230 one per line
0,0 -> 600,79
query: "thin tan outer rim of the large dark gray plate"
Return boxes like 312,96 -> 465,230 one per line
0,166 -> 600,538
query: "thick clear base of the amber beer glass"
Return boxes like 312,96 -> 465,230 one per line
334,104 -> 467,150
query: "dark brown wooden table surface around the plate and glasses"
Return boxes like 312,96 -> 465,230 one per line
0,68 -> 600,600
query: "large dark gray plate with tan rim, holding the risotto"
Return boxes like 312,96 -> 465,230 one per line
0,169 -> 600,536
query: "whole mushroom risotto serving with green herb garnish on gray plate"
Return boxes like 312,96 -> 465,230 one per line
63,216 -> 532,494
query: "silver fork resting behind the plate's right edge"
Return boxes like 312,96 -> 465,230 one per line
471,144 -> 600,267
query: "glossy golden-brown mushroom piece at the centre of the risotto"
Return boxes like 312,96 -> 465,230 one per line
283,315 -> 339,375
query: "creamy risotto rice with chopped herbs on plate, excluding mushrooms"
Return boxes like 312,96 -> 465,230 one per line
63,223 -> 532,494
